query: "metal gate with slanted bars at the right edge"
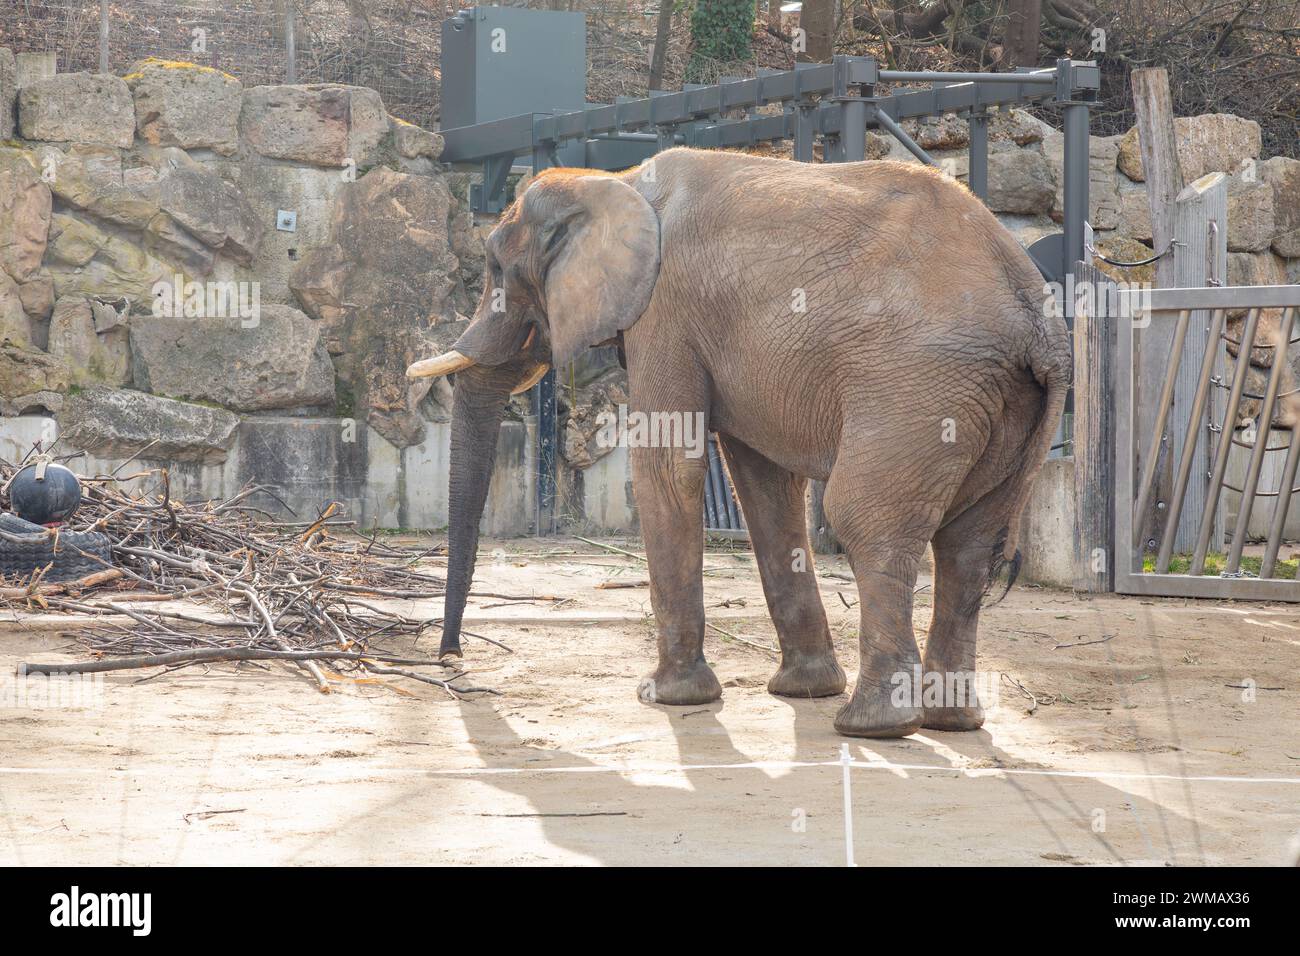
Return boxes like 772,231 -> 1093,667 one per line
1110,286 -> 1300,601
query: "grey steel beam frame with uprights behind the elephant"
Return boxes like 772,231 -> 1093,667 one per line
441,56 -> 1101,535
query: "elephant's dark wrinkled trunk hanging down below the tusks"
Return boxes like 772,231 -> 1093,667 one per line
439,365 -> 519,657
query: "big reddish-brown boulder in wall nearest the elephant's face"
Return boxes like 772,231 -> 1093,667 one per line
289,166 -> 458,447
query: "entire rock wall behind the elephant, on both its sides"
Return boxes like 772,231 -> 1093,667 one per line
0,49 -> 1300,532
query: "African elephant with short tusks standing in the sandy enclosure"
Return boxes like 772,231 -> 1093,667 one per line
408,148 -> 1071,737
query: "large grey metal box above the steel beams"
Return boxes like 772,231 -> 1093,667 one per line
441,7 -> 586,129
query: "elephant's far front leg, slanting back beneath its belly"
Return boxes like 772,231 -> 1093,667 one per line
718,434 -> 845,697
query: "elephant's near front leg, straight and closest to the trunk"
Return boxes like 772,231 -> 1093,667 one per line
632,444 -> 723,704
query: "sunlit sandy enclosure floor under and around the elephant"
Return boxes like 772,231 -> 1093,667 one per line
0,538 -> 1300,865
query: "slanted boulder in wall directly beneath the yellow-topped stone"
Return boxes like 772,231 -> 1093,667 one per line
159,148 -> 265,264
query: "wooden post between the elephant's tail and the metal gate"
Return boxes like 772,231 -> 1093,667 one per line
1073,263 -> 1127,593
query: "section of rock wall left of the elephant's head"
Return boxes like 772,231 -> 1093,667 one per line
0,49 -> 501,524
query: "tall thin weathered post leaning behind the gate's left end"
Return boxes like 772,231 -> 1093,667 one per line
1131,69 -> 1186,556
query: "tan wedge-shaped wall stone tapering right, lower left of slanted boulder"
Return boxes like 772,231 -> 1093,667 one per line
48,213 -> 174,307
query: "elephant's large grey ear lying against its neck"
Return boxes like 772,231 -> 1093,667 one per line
529,176 -> 659,367
